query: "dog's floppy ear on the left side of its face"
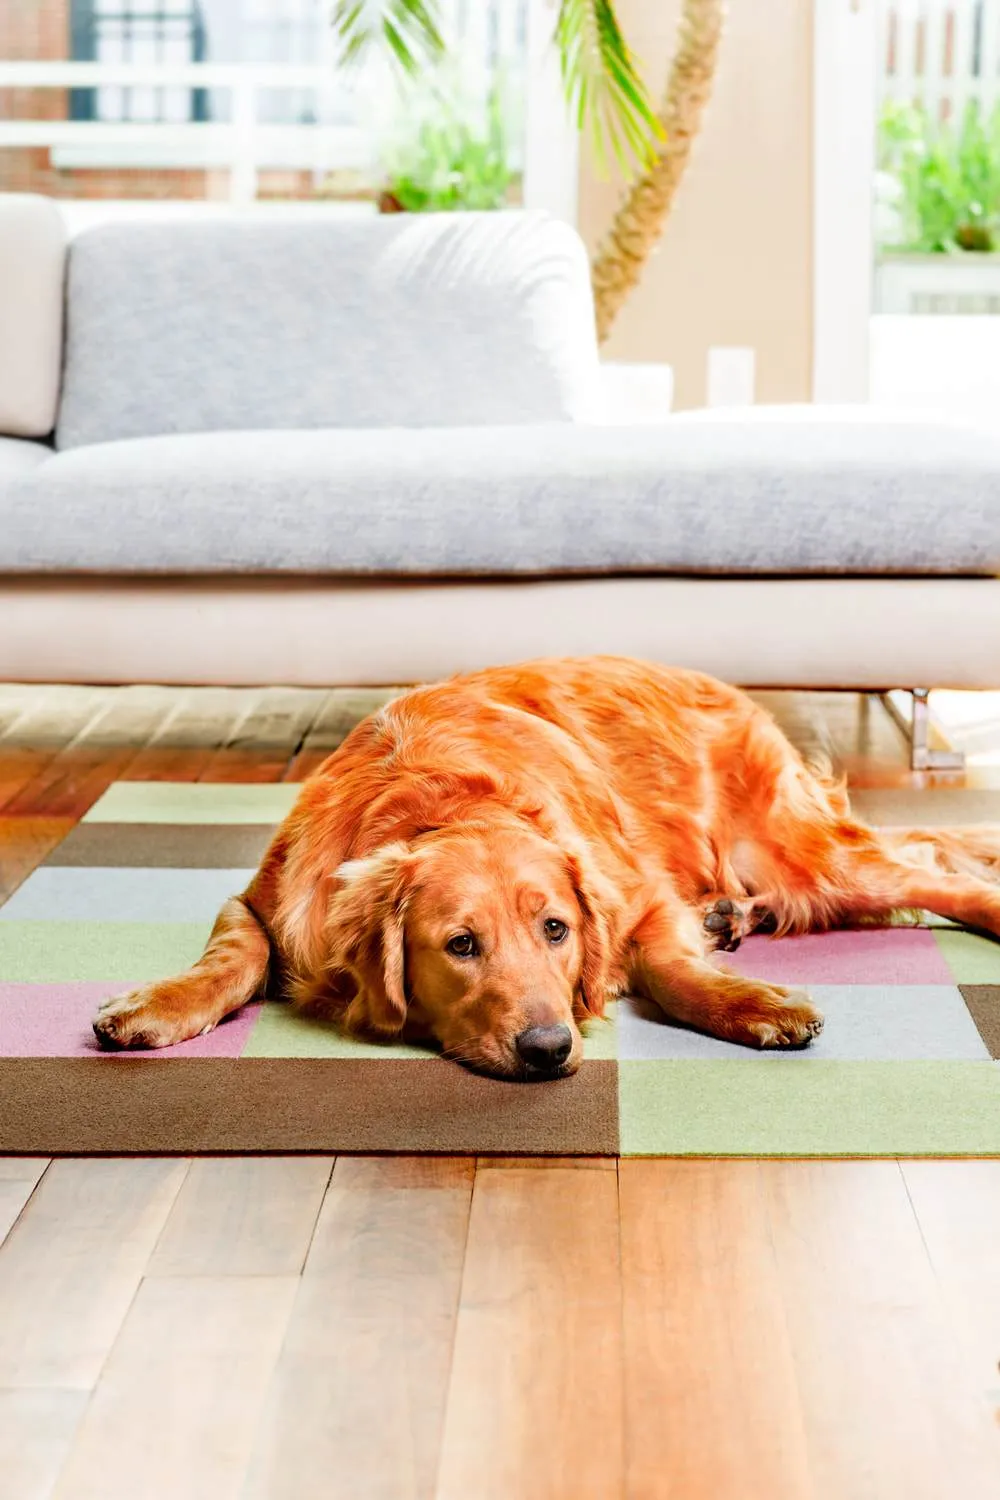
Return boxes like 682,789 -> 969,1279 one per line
327,843 -> 412,1037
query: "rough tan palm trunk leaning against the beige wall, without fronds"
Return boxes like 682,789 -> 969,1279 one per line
591,0 -> 726,344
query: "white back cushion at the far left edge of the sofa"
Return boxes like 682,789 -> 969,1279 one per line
0,194 -> 66,438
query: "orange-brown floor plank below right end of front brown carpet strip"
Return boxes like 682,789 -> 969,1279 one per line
436,1167 -> 624,1500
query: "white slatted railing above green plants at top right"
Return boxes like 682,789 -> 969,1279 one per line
877,0 -> 1000,119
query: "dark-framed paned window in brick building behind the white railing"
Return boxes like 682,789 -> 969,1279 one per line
69,0 -> 208,123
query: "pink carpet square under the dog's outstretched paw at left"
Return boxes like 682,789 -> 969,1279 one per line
0,983 -> 261,1059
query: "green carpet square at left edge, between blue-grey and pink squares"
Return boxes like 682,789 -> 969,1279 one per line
0,921 -> 211,984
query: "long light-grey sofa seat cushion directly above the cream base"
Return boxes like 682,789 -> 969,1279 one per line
0,419 -> 1000,576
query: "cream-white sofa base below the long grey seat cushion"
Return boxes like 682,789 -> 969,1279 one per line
0,578 -> 1000,690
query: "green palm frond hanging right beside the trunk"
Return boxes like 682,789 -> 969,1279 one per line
555,0 -> 663,173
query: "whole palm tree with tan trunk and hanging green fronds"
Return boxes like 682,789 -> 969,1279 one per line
333,0 -> 724,341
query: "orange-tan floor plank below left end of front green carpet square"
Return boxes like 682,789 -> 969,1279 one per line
619,1161 -> 813,1500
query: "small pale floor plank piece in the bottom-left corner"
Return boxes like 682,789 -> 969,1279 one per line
0,1391 -> 87,1500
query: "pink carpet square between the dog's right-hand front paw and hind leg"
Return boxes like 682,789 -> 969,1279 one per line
721,927 -> 955,986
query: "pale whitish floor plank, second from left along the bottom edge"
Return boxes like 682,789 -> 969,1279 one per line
55,1277 -> 296,1500
